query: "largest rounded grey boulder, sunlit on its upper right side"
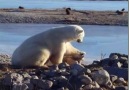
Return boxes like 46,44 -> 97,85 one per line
91,70 -> 110,85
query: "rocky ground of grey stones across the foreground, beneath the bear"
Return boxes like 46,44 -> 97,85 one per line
0,53 -> 128,90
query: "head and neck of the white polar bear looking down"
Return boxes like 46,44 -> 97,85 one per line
52,25 -> 85,43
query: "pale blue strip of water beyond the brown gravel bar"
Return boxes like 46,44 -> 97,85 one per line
0,0 -> 128,11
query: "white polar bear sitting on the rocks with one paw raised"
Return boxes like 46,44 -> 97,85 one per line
11,25 -> 85,66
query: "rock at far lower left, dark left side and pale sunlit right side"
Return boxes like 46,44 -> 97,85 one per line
3,73 -> 23,86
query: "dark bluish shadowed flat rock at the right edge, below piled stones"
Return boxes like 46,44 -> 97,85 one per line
103,67 -> 128,80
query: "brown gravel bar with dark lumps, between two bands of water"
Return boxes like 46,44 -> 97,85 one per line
0,9 -> 128,26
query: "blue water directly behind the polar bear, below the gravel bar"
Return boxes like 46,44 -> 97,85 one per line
0,24 -> 128,62
